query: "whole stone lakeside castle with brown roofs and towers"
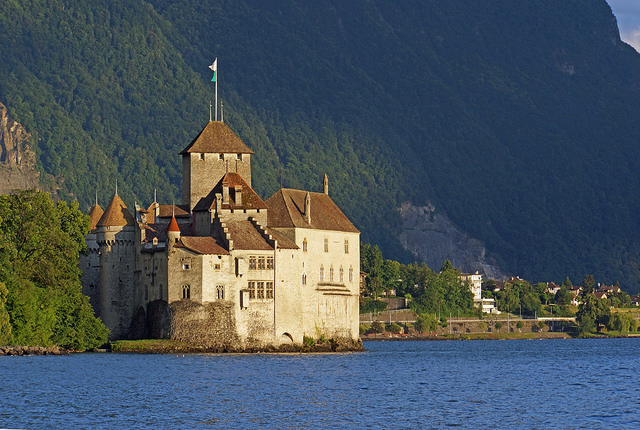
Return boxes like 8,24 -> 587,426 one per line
80,121 -> 360,349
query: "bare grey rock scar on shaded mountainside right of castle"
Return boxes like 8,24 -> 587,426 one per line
399,202 -> 507,279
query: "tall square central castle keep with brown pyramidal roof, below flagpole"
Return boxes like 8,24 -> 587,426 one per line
180,121 -> 253,211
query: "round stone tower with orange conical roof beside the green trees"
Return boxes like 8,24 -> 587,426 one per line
96,194 -> 137,339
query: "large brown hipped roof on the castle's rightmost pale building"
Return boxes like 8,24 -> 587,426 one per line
266,188 -> 359,233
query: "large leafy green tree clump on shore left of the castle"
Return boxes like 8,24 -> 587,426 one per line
0,190 -> 108,350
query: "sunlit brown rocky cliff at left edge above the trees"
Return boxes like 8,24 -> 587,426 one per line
0,103 -> 39,194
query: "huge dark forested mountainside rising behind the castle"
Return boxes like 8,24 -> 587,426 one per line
0,0 -> 640,291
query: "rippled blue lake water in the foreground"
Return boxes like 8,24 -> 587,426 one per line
0,339 -> 640,429
